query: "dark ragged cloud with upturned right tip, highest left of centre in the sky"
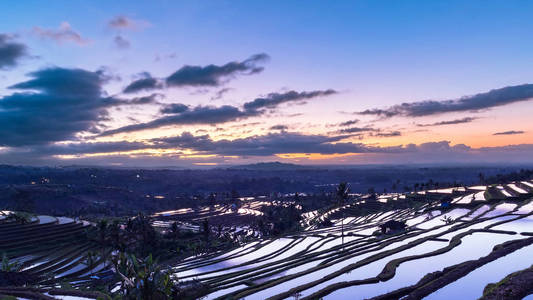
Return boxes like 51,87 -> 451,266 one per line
166,53 -> 269,87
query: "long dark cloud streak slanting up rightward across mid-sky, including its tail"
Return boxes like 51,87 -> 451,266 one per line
101,90 -> 336,136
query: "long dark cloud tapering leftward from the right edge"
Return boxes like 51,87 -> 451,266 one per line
358,84 -> 533,118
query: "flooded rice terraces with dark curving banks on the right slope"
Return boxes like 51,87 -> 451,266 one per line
172,182 -> 533,299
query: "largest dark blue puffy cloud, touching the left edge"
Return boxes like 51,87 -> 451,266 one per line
0,67 -> 151,147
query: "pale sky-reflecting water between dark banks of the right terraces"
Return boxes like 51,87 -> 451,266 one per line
179,202 -> 533,300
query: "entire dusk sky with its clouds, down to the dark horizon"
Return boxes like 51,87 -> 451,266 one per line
0,0 -> 533,167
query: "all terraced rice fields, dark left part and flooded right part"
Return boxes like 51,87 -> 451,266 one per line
0,176 -> 533,299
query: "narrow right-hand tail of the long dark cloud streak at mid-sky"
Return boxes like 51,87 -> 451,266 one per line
244,89 -> 337,111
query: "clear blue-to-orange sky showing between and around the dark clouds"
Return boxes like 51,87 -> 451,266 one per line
0,1 -> 533,165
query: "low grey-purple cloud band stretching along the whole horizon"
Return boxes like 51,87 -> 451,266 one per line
4,131 -> 533,165
